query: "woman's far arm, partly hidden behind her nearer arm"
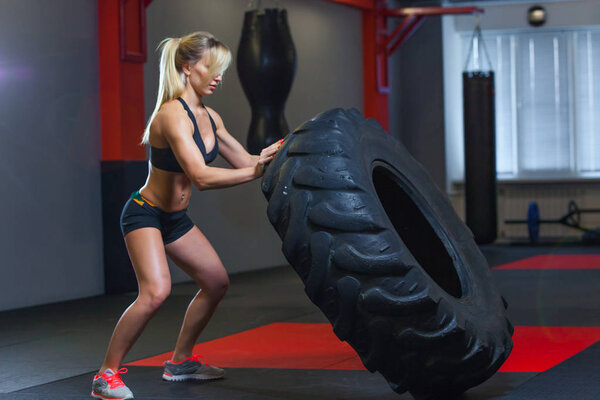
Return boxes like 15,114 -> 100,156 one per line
206,107 -> 279,168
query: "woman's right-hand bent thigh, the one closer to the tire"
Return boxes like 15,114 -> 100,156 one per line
165,226 -> 229,290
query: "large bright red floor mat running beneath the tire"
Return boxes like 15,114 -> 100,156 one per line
126,323 -> 600,372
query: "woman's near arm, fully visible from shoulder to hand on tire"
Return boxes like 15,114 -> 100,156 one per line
161,109 -> 274,190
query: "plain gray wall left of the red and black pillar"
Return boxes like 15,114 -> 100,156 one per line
0,0 -> 104,310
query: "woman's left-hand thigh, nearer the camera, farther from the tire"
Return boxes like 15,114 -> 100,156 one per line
125,227 -> 171,300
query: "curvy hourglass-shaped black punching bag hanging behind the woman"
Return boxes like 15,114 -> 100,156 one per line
237,8 -> 296,154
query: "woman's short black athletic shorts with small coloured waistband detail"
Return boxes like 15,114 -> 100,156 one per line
121,190 -> 194,244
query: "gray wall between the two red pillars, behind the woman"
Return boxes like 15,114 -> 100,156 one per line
146,0 -> 363,282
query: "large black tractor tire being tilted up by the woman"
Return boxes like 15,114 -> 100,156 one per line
262,109 -> 513,399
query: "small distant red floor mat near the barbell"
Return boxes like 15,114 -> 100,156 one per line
493,254 -> 600,269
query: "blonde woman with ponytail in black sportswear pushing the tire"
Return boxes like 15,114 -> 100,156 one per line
92,32 -> 280,399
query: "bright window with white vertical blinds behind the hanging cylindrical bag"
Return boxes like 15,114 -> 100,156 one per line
461,29 -> 600,179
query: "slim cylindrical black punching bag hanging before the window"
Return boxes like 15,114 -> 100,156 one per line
463,71 -> 498,244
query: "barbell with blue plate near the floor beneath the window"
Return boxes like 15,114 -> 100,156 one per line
504,200 -> 600,244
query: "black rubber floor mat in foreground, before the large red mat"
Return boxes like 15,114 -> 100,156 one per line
11,367 -> 535,400
